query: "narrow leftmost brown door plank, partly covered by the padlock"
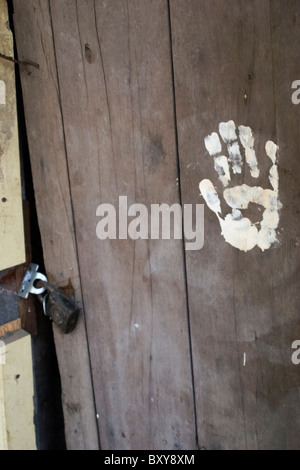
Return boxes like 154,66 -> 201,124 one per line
14,0 -> 99,449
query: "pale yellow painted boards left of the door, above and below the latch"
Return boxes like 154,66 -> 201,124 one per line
0,0 -> 36,450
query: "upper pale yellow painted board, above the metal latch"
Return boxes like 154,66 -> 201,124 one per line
0,0 -> 25,271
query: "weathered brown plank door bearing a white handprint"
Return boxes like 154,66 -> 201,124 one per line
14,0 -> 300,450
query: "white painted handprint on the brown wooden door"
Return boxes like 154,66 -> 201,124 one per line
199,121 -> 281,251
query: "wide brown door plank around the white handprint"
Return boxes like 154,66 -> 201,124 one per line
170,0 -> 300,449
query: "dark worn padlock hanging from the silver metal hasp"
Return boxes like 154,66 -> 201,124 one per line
39,281 -> 80,334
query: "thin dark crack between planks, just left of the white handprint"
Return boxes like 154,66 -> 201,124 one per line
166,0 -> 200,449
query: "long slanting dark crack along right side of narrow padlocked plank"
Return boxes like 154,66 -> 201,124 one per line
48,0 -> 101,450
